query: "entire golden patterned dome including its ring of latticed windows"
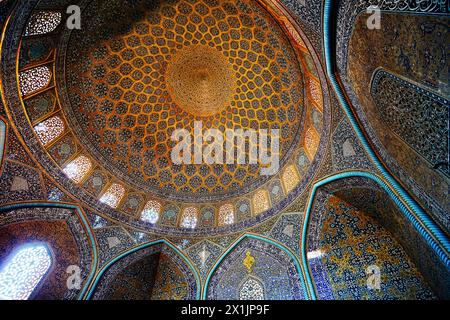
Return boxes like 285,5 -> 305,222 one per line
4,0 -> 329,235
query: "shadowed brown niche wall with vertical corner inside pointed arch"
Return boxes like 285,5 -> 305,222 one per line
89,242 -> 200,300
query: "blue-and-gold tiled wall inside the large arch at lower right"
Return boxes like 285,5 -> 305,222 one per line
308,195 -> 434,300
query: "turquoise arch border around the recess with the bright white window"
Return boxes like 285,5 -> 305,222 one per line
0,202 -> 98,300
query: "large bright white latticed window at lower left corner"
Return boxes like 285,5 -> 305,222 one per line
0,244 -> 52,300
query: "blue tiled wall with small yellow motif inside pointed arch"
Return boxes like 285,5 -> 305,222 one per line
207,238 -> 306,300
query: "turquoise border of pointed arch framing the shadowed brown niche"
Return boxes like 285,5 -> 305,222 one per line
83,239 -> 201,300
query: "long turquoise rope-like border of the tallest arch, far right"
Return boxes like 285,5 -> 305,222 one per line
322,0 -> 450,268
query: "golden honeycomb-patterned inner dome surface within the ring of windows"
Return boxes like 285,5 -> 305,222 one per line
61,1 -> 303,200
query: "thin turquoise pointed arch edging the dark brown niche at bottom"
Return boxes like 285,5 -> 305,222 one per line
84,239 -> 201,300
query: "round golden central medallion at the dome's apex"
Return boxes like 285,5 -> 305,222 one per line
166,45 -> 236,116
